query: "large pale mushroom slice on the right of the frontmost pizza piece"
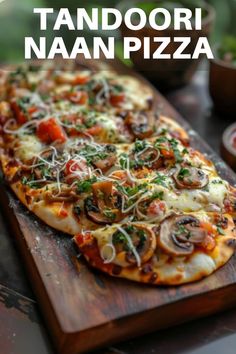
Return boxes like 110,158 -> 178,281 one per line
158,215 -> 207,256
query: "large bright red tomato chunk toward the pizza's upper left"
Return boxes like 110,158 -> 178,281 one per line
36,118 -> 67,144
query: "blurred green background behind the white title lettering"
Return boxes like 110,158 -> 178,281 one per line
0,0 -> 236,63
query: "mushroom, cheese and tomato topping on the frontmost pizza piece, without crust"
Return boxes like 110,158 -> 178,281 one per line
76,213 -> 234,272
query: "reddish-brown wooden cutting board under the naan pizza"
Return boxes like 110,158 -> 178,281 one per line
0,59 -> 236,354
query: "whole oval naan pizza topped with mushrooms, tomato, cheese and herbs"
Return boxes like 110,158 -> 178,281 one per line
0,65 -> 236,284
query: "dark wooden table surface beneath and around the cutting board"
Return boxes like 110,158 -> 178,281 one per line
0,65 -> 236,354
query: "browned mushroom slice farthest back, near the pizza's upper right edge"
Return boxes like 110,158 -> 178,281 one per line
125,111 -> 157,139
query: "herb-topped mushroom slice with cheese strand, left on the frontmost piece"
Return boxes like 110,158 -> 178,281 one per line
112,225 -> 156,266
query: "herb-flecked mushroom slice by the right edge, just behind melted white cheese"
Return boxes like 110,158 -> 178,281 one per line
173,166 -> 209,189
